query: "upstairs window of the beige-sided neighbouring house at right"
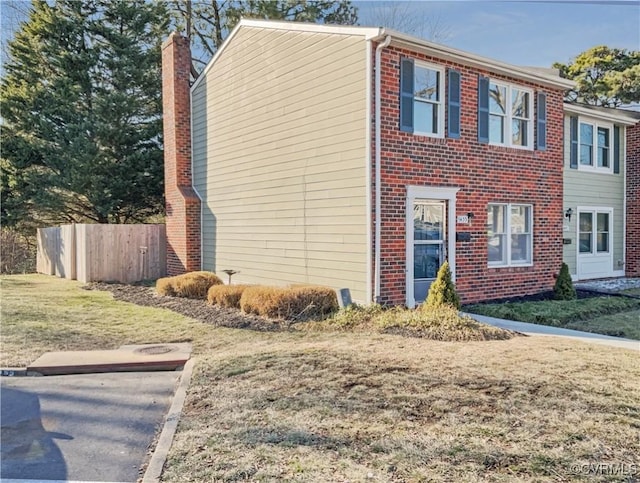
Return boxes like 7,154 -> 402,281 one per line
570,118 -> 620,172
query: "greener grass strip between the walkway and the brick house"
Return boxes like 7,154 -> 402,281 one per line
464,296 -> 640,339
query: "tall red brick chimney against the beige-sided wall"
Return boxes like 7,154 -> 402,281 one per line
162,32 -> 200,275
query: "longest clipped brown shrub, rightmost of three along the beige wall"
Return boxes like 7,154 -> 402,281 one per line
240,285 -> 338,320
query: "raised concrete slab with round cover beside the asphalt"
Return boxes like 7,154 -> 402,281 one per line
26,343 -> 191,376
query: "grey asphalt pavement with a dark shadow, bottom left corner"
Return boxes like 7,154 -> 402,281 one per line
0,371 -> 181,482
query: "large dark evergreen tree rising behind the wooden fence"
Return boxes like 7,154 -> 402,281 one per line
0,0 -> 168,225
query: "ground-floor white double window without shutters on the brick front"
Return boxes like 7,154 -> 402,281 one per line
487,204 -> 533,267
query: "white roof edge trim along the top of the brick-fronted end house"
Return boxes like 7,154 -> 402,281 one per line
192,18 -> 575,89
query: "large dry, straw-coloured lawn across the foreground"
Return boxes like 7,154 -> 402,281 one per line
2,276 -> 640,482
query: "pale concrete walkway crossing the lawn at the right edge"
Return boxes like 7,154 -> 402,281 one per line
466,314 -> 640,351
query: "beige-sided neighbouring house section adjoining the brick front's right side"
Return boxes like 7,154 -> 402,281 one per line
563,103 -> 638,280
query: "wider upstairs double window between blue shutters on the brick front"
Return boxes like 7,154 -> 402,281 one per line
489,81 -> 533,148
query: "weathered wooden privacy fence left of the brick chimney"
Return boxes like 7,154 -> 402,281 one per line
36,224 -> 167,283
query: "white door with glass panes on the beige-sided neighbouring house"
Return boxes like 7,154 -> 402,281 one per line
577,207 -> 613,280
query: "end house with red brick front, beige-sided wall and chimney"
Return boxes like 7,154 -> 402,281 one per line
163,20 -> 572,306
